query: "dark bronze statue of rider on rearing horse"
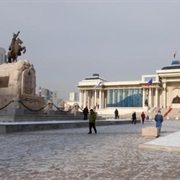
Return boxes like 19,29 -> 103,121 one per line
7,31 -> 26,63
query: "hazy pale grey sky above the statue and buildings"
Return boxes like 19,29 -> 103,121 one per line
0,0 -> 180,99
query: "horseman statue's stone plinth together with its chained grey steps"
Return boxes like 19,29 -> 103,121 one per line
0,60 -> 83,122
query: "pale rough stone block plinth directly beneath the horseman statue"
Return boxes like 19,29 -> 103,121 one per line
0,60 -> 45,121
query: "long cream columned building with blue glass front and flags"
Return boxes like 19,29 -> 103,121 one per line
77,60 -> 180,114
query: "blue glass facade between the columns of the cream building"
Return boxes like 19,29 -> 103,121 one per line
107,88 -> 142,107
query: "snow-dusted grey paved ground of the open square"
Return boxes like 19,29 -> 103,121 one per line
0,121 -> 180,180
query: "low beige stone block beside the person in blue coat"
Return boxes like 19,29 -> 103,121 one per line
142,127 -> 160,138
